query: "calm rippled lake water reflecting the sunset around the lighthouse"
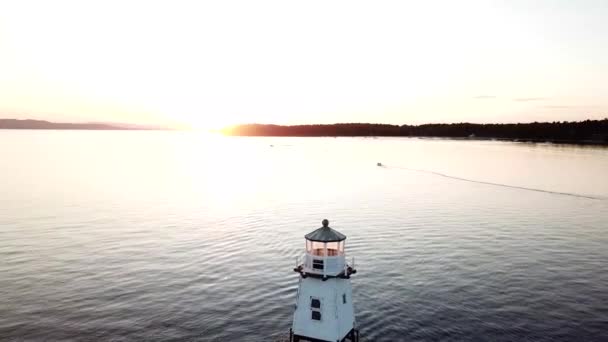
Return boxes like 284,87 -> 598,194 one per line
0,131 -> 608,341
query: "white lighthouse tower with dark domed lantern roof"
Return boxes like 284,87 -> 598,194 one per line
290,220 -> 359,342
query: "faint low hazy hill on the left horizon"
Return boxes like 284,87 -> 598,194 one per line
0,119 -> 158,130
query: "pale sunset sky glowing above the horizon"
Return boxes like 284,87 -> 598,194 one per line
0,1 -> 608,128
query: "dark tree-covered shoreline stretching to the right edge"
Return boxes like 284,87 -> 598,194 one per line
222,118 -> 608,144
